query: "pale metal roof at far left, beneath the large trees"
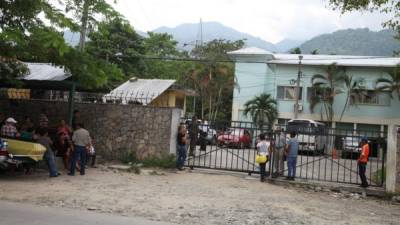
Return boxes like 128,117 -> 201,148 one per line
23,63 -> 71,81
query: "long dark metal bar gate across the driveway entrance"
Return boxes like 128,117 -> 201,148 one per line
186,121 -> 386,186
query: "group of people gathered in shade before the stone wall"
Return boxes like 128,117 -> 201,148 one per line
0,109 -> 96,177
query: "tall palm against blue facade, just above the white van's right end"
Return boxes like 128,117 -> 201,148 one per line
310,63 -> 346,122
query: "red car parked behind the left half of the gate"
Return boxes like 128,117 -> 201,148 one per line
218,128 -> 251,148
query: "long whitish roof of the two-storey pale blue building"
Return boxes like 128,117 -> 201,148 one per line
228,47 -> 400,67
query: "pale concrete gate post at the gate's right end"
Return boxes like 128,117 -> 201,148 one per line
386,124 -> 400,193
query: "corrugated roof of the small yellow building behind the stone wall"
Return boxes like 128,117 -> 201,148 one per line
104,78 -> 175,105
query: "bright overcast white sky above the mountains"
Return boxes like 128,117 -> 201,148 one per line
109,0 -> 388,43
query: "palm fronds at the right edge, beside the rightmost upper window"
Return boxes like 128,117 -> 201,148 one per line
376,65 -> 400,99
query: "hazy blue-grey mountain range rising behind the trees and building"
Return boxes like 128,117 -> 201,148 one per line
64,22 -> 400,56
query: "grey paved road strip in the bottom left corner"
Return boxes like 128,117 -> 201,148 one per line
0,201 -> 173,225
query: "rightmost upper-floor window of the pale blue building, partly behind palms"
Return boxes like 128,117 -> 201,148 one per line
351,90 -> 390,106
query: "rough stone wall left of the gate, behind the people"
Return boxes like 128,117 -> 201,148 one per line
0,100 -> 180,159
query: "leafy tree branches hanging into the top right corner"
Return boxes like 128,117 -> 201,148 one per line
329,0 -> 400,35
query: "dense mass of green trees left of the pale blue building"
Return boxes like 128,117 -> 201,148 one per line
0,0 -> 244,121
